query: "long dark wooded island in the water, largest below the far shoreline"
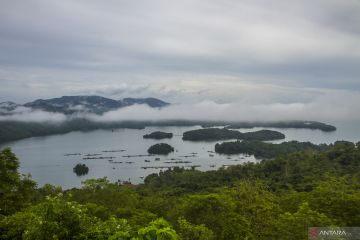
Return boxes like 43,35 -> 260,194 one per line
183,128 -> 285,141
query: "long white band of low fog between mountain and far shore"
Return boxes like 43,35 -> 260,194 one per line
0,92 -> 360,123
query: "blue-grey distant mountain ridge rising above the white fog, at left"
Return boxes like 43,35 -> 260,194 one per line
0,96 -> 169,115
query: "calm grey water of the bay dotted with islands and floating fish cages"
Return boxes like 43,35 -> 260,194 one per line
0,122 -> 360,189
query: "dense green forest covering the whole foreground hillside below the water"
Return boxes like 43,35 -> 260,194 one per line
0,142 -> 360,240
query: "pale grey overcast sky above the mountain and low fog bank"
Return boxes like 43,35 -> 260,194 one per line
0,0 -> 360,110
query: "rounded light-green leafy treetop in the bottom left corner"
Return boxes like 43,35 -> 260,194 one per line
0,197 -> 91,240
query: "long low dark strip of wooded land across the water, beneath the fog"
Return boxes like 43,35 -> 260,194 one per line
0,118 -> 336,143
